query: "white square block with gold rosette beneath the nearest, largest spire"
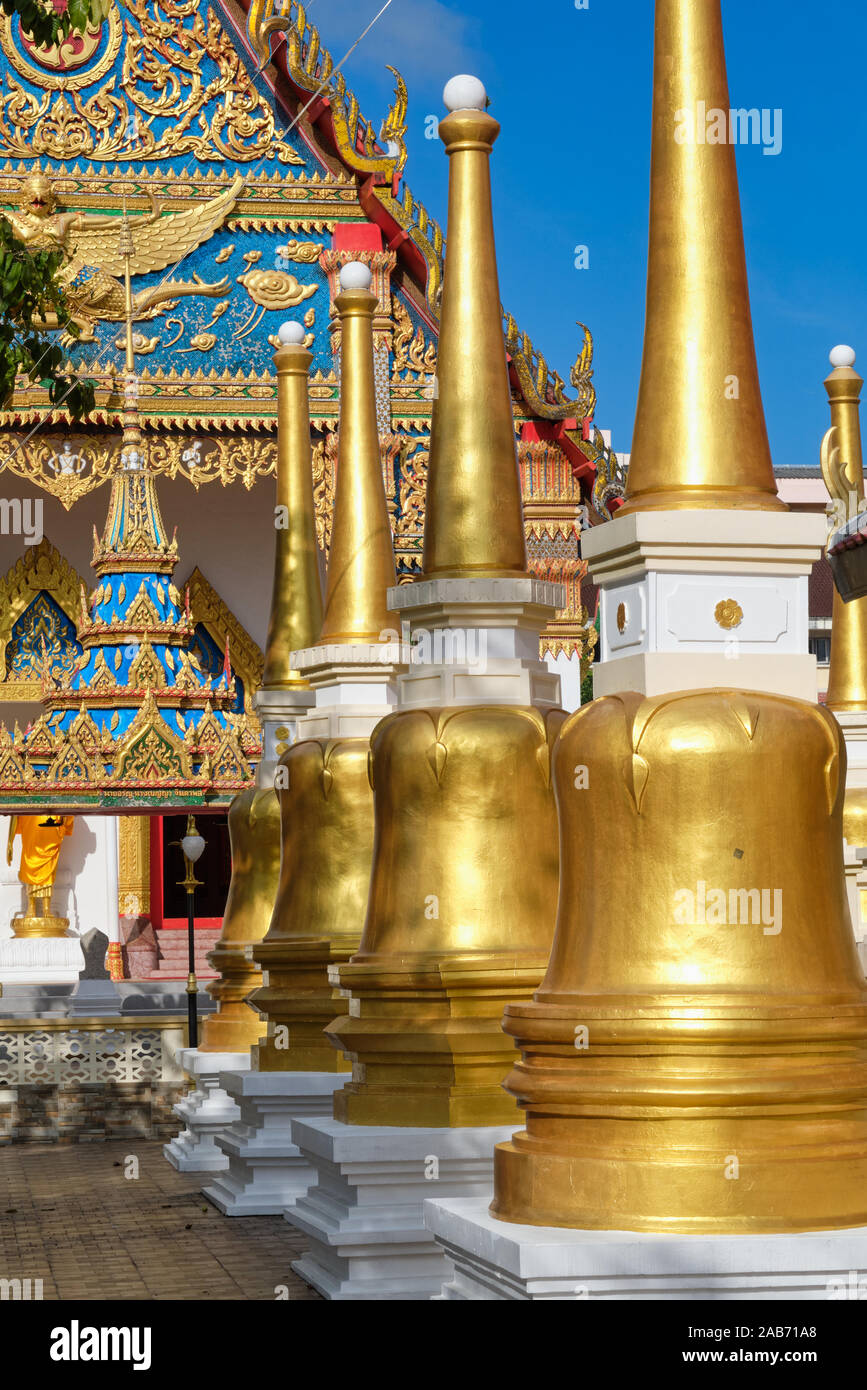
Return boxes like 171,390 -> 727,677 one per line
581,509 -> 827,703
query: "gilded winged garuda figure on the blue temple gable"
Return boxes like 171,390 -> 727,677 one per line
0,171 -> 243,342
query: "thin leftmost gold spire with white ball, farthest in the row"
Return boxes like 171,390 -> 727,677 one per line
263,322 -> 322,689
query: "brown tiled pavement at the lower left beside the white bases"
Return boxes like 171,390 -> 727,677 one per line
0,1140 -> 318,1300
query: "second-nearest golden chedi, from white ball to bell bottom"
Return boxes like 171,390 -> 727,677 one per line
328,78 -> 565,1126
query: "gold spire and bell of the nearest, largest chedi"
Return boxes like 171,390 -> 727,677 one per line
492,0 -> 867,1233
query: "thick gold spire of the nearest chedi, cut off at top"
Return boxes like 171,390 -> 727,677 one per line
621,0 -> 786,514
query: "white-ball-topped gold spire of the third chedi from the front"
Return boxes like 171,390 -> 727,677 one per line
318,261 -> 396,646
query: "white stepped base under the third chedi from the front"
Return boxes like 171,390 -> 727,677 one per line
203,1072 -> 346,1216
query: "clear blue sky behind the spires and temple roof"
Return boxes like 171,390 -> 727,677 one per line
308,0 -> 867,467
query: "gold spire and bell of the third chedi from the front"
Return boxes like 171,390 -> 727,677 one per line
254,271 -> 395,1072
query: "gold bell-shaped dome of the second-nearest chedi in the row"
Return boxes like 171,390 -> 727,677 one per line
328,706 -> 565,1126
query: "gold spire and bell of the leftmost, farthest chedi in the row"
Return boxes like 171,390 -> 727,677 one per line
200,322 -> 322,1052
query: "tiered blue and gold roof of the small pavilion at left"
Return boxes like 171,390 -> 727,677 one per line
0,439 -> 261,812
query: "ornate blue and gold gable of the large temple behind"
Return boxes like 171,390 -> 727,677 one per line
0,0 -> 595,442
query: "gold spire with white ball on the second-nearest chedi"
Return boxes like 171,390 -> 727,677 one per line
422,76 -> 527,578
